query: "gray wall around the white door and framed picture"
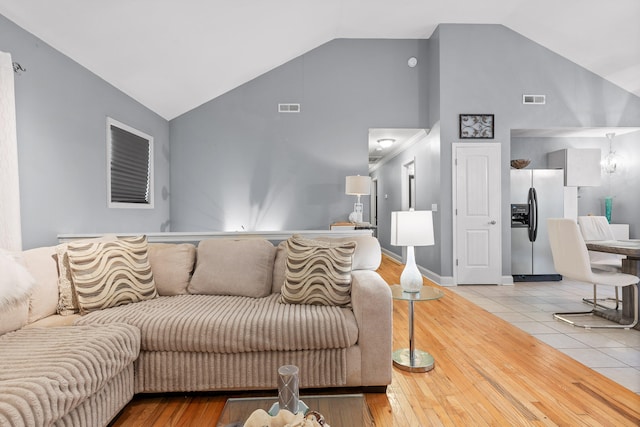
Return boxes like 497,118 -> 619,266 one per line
438,24 -> 640,276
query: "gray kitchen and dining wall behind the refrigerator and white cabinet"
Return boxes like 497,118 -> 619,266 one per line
511,132 -> 640,239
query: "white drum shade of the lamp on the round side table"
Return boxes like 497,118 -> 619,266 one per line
391,211 -> 435,246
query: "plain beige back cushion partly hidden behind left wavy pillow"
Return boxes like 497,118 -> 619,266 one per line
149,243 -> 196,295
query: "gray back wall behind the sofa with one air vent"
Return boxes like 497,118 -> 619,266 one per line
170,39 -> 428,231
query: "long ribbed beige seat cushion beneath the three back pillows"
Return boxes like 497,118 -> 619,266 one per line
75,294 -> 358,353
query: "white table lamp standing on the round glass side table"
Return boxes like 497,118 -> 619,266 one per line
391,210 -> 434,292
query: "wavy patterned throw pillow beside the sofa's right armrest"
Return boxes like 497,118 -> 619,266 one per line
280,235 -> 356,306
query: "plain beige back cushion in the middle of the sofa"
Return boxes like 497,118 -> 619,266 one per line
188,239 -> 276,298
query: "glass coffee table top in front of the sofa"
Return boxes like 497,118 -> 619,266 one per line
216,393 -> 374,427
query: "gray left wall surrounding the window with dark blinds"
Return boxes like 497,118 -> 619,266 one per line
0,16 -> 170,249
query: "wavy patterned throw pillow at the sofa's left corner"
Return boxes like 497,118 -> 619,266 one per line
67,236 -> 158,314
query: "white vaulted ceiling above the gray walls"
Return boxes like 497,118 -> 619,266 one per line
0,0 -> 640,119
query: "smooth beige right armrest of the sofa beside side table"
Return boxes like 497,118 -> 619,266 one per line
351,270 -> 393,386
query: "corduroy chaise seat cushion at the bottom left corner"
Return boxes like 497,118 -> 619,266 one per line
0,324 -> 140,426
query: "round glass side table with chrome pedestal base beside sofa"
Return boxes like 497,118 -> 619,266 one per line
391,285 -> 444,372
